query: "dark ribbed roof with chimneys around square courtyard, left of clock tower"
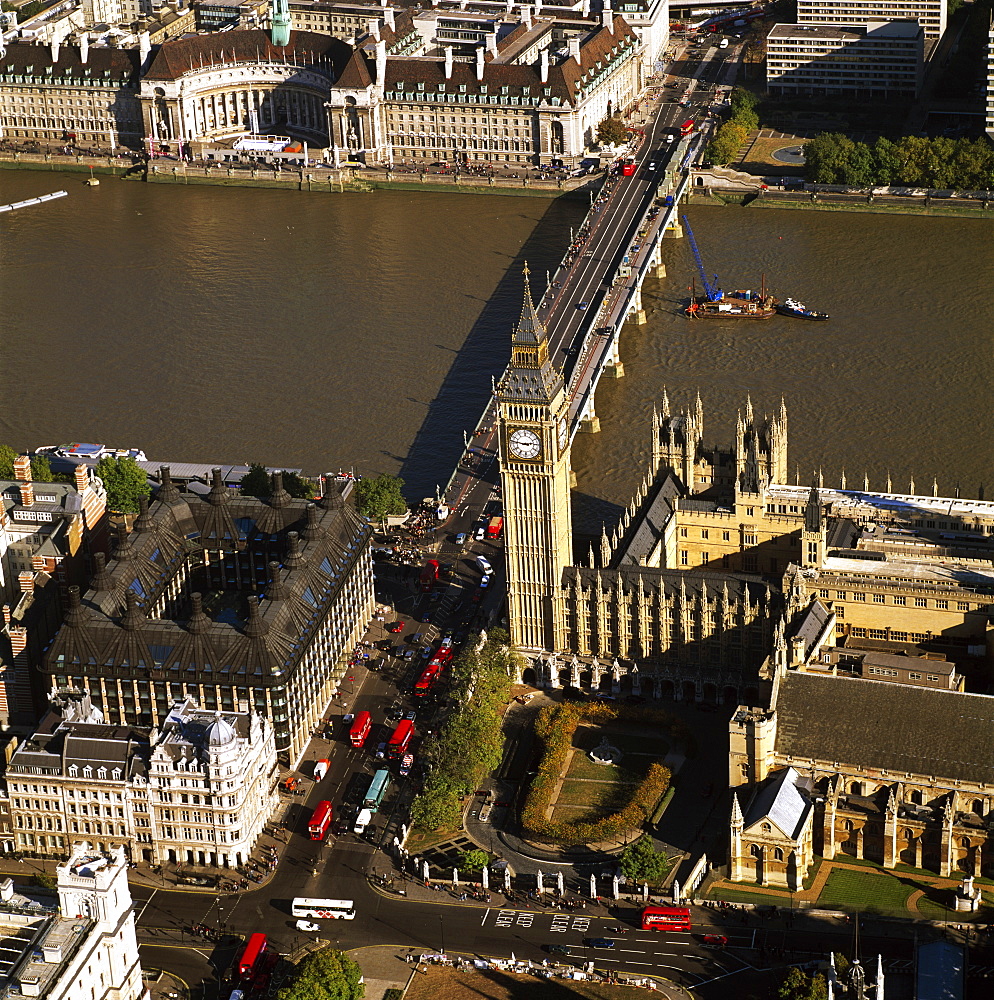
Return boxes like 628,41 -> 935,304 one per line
42,480 -> 369,686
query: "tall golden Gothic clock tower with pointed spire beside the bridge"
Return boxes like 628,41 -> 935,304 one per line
497,264 -> 573,652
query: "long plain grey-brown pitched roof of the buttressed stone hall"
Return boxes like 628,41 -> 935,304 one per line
775,671 -> 994,784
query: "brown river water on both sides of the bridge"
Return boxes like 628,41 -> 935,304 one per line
0,171 -> 994,527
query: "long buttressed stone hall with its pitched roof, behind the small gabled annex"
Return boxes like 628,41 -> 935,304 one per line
729,671 -> 994,884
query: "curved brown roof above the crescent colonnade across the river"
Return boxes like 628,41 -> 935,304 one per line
141,28 -> 353,80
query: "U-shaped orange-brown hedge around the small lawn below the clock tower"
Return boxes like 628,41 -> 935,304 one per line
521,702 -> 686,845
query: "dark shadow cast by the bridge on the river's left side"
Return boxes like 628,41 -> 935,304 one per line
399,198 -> 587,500
